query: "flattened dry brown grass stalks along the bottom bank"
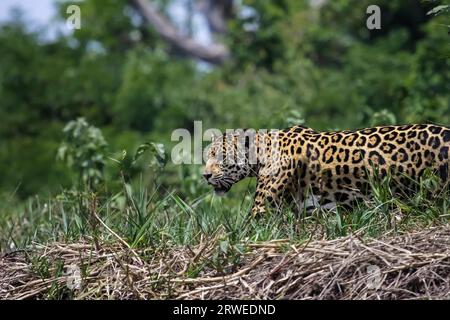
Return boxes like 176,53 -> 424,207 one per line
0,226 -> 450,299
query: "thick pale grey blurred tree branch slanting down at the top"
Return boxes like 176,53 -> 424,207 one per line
132,0 -> 230,64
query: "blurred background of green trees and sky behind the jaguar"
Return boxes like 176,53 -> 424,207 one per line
0,0 -> 450,201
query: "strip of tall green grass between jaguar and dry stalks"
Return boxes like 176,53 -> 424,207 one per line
0,170 -> 450,251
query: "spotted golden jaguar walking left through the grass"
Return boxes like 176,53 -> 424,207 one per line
203,124 -> 450,216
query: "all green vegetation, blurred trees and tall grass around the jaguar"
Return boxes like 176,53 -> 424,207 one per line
0,0 -> 450,255
